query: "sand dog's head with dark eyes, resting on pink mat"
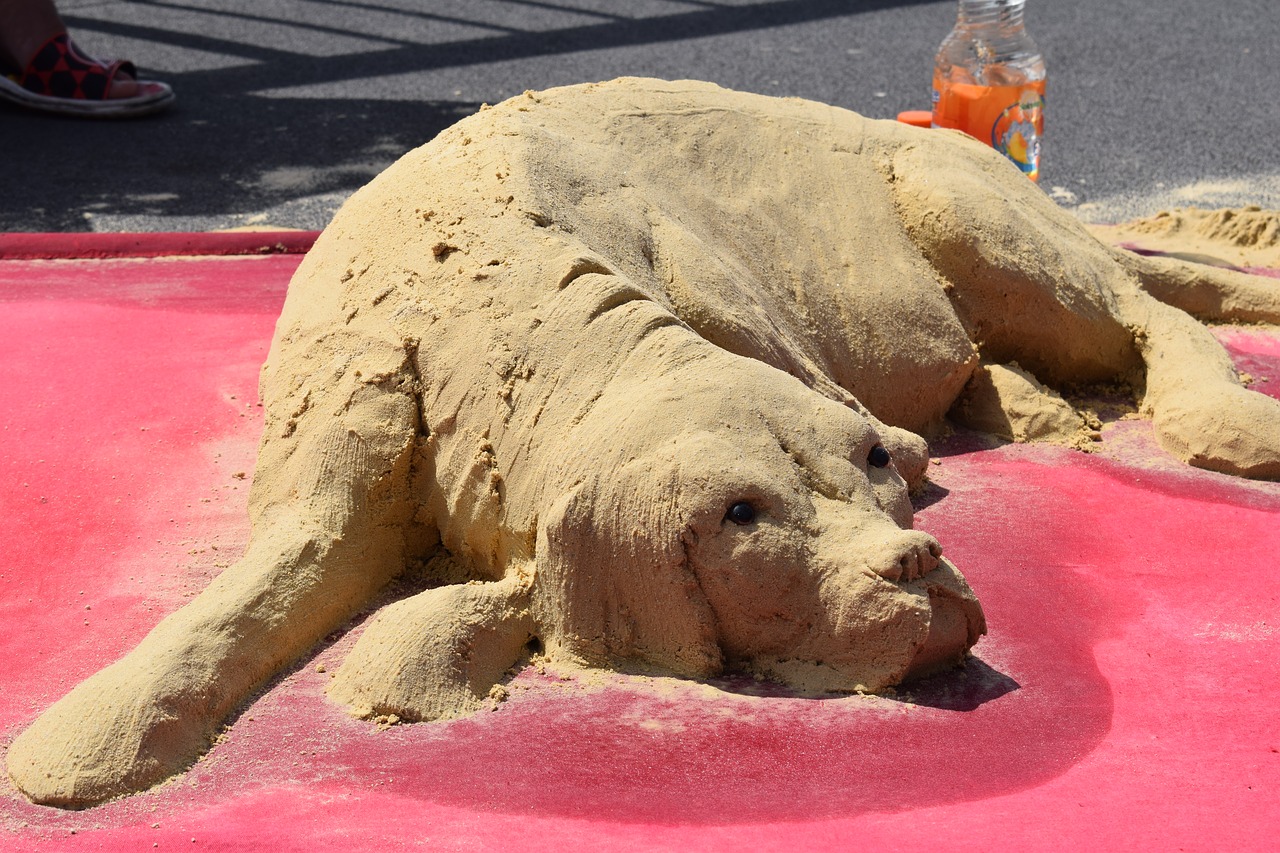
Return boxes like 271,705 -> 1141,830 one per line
524,353 -> 986,690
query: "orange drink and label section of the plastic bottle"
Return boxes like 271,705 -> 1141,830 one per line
933,76 -> 1044,181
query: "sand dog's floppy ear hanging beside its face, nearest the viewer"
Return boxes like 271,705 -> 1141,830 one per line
532,460 -> 723,678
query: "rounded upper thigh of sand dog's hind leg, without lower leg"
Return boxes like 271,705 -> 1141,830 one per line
882,128 -> 1142,387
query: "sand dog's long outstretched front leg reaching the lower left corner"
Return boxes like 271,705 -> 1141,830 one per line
8,332 -> 419,807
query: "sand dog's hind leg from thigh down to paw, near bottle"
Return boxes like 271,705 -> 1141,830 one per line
888,131 -> 1280,479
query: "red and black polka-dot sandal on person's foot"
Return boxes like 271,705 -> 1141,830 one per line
0,32 -> 177,118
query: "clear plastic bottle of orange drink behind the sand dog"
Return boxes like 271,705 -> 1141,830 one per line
932,0 -> 1044,181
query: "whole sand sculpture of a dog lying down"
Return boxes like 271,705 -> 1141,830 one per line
8,79 -> 1280,806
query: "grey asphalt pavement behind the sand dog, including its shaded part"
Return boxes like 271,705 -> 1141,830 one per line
0,0 -> 1280,232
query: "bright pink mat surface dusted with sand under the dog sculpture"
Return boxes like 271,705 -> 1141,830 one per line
0,255 -> 1280,850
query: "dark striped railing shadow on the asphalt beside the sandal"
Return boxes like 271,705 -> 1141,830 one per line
0,0 -> 931,232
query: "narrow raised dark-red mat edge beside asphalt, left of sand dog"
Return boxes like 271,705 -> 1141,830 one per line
0,231 -> 320,260
